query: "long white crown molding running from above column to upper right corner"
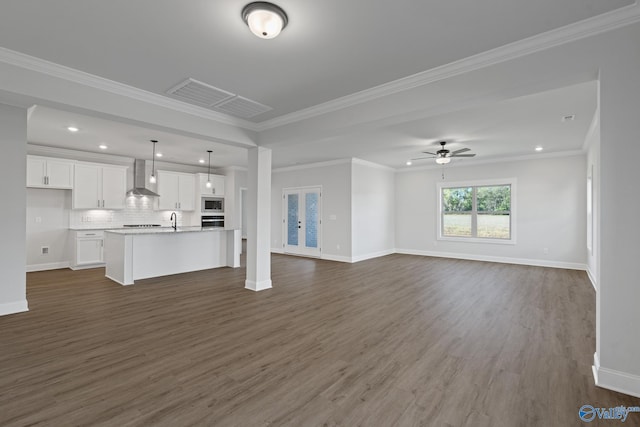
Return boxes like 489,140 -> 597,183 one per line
257,1 -> 640,131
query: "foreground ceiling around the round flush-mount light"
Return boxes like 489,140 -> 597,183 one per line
0,0 -> 634,121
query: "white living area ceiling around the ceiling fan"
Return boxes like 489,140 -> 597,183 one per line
273,81 -> 597,169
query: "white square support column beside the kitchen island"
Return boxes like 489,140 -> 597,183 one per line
245,147 -> 271,291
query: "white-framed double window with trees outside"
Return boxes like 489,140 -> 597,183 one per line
438,179 -> 515,243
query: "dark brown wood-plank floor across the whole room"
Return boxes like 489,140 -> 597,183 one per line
0,255 -> 640,427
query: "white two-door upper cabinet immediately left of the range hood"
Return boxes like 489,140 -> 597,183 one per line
72,163 -> 127,209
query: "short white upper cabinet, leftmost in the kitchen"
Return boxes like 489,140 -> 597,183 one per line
27,156 -> 74,189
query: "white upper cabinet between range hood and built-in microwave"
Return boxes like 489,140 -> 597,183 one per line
157,171 -> 196,211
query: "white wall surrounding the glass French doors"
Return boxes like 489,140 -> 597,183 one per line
271,159 -> 351,261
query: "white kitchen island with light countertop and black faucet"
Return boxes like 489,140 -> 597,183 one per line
104,227 -> 241,285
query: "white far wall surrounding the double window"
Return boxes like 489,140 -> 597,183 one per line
396,155 -> 586,268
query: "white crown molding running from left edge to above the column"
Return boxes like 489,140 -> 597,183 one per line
0,47 -> 259,132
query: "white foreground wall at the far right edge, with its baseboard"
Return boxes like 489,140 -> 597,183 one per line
596,23 -> 640,397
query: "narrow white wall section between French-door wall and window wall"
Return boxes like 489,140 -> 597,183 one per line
351,159 -> 396,262
